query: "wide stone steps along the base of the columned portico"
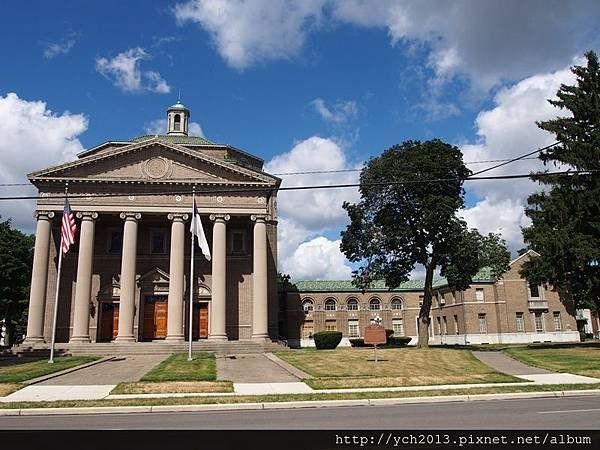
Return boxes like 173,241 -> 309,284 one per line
12,341 -> 287,356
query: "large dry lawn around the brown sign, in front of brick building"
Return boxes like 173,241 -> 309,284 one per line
277,348 -> 522,389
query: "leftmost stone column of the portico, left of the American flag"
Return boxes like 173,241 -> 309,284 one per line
25,211 -> 54,344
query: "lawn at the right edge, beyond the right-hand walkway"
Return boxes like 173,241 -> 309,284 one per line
504,346 -> 600,378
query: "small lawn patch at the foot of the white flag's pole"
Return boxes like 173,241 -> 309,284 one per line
140,352 -> 217,382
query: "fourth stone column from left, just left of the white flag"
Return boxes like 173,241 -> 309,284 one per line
166,214 -> 188,341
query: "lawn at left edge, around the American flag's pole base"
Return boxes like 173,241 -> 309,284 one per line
0,356 -> 99,383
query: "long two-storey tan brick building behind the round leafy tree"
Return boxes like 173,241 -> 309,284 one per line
280,251 -> 579,347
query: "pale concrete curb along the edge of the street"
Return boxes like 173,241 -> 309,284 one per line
0,389 -> 600,416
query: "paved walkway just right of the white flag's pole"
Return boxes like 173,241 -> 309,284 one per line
217,354 -> 299,383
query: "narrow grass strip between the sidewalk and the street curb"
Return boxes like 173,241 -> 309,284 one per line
0,383 -> 600,409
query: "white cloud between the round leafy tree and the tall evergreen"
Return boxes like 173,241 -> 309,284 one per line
461,59 -> 574,251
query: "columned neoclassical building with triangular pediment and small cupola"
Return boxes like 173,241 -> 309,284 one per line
25,101 -> 281,344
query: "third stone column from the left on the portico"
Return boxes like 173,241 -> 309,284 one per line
115,212 -> 142,342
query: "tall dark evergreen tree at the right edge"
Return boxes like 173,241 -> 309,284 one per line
522,51 -> 600,310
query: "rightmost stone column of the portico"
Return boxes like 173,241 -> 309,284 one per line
250,215 -> 269,340
